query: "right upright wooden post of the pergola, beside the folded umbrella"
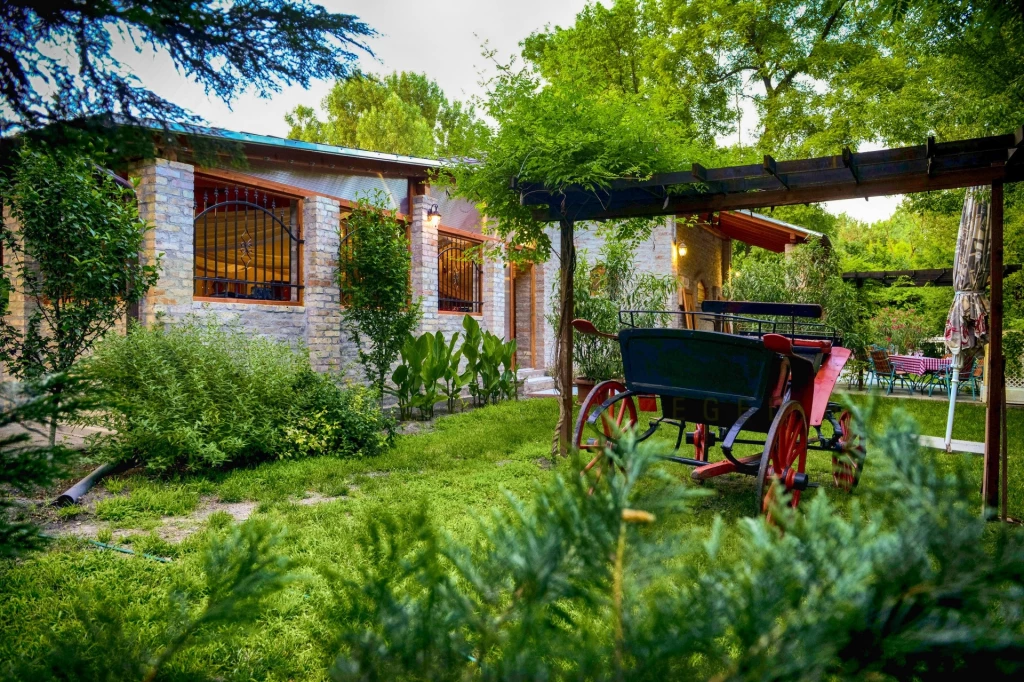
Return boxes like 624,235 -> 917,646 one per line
981,181 -> 1007,512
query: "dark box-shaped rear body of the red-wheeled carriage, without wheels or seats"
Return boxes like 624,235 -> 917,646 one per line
618,329 -> 784,433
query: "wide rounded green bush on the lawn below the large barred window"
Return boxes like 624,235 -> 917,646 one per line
84,318 -> 390,472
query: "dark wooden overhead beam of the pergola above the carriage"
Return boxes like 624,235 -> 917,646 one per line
513,130 -> 1024,221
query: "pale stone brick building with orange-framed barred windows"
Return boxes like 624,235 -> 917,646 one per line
2,129 -> 814,376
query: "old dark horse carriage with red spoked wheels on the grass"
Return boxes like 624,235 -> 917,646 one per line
572,301 -> 865,513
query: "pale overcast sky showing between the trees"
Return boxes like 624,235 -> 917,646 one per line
115,0 -> 900,222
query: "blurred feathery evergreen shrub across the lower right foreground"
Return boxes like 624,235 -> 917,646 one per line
324,403 -> 1024,681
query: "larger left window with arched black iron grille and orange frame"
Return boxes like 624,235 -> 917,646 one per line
193,178 -> 302,303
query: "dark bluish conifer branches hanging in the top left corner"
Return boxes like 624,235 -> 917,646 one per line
0,0 -> 375,133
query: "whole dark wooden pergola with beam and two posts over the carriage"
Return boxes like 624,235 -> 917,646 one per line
524,127 -> 1024,508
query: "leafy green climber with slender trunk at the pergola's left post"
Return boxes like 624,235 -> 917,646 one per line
449,53 -> 699,453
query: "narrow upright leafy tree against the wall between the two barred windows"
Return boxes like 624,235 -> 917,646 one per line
338,191 -> 420,406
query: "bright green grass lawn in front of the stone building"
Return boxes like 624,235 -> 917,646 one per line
0,398 -> 1024,680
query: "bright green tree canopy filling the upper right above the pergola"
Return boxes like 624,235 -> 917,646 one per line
523,0 -> 1024,157
